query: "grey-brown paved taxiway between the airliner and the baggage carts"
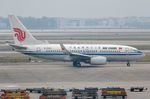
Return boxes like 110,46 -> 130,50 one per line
0,62 -> 150,99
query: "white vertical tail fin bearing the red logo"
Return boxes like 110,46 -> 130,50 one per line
8,15 -> 43,45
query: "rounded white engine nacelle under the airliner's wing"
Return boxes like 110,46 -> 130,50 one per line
90,56 -> 107,65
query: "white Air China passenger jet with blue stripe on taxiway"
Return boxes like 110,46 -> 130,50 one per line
8,15 -> 145,67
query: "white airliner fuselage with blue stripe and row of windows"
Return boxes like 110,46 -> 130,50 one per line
18,44 -> 144,61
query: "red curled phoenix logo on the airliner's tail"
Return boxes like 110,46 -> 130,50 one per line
13,28 -> 26,42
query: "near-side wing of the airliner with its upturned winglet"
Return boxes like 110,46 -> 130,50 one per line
60,44 -> 91,60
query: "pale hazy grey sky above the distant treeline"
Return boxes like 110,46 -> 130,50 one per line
0,0 -> 150,18
